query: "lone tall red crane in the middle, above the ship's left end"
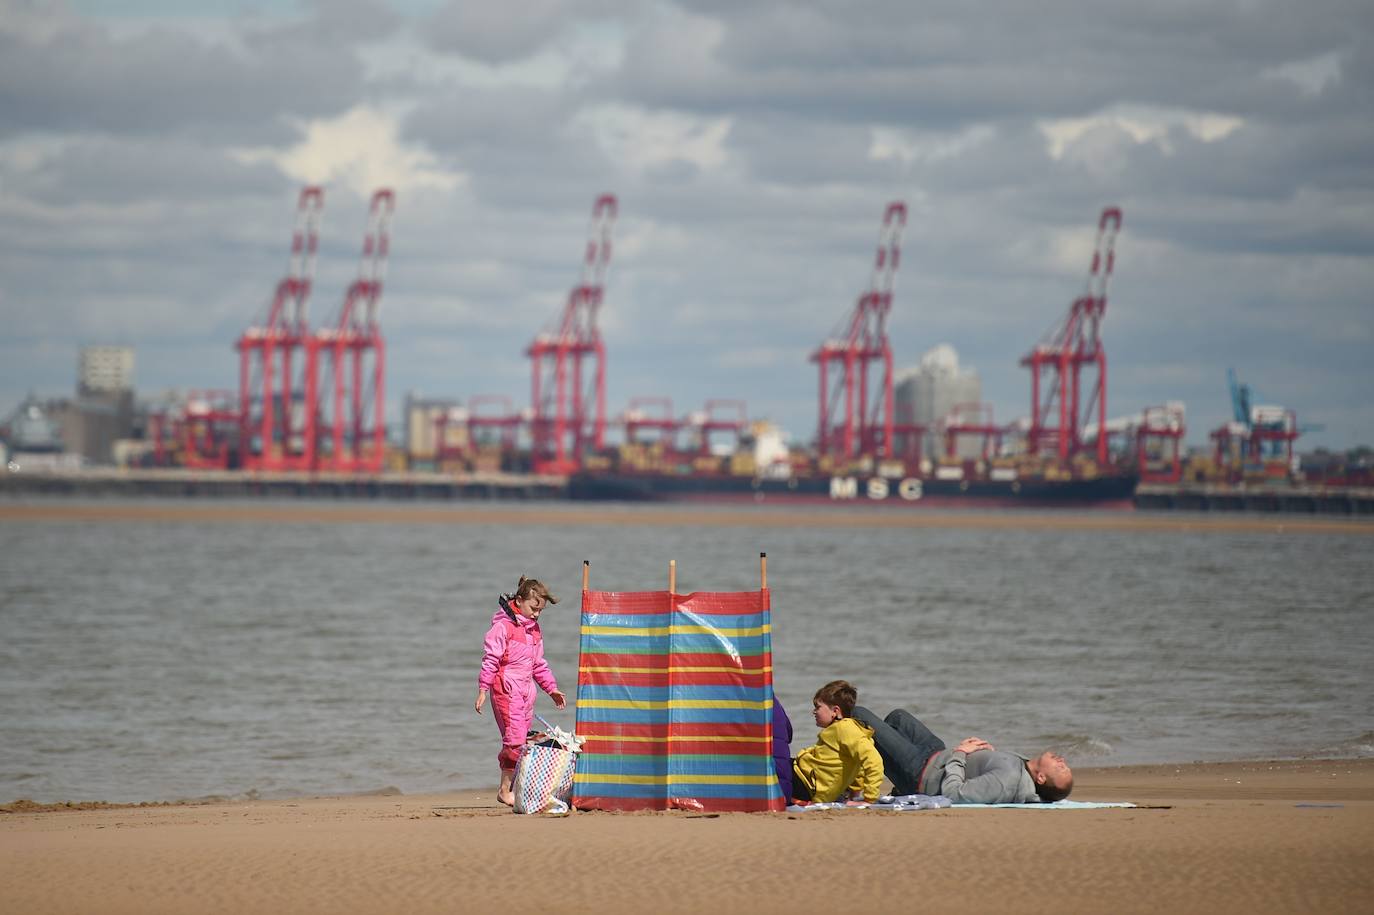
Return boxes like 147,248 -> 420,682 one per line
525,194 -> 618,474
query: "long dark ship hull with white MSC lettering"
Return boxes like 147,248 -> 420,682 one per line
567,474 -> 1136,508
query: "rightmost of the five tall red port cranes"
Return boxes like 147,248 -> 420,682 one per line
1021,206 -> 1121,464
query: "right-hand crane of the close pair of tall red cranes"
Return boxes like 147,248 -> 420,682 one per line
305,188 -> 396,474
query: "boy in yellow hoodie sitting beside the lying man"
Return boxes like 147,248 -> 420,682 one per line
791,680 -> 882,804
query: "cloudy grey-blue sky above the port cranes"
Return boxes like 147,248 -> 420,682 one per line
0,0 -> 1374,448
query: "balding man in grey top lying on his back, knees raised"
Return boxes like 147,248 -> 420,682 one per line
853,706 -> 1073,804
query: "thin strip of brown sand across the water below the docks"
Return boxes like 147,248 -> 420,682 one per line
0,501 -> 1374,534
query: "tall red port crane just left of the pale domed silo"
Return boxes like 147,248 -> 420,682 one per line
811,201 -> 907,460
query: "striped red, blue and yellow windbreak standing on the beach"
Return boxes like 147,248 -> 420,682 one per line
573,589 -> 786,812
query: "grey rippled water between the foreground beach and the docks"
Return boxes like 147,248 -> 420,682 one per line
0,501 -> 1374,801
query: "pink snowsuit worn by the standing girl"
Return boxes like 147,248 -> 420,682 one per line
477,610 -> 558,769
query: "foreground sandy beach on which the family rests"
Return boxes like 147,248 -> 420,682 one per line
0,760 -> 1374,915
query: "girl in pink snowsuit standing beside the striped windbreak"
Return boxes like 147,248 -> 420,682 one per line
473,576 -> 567,805
